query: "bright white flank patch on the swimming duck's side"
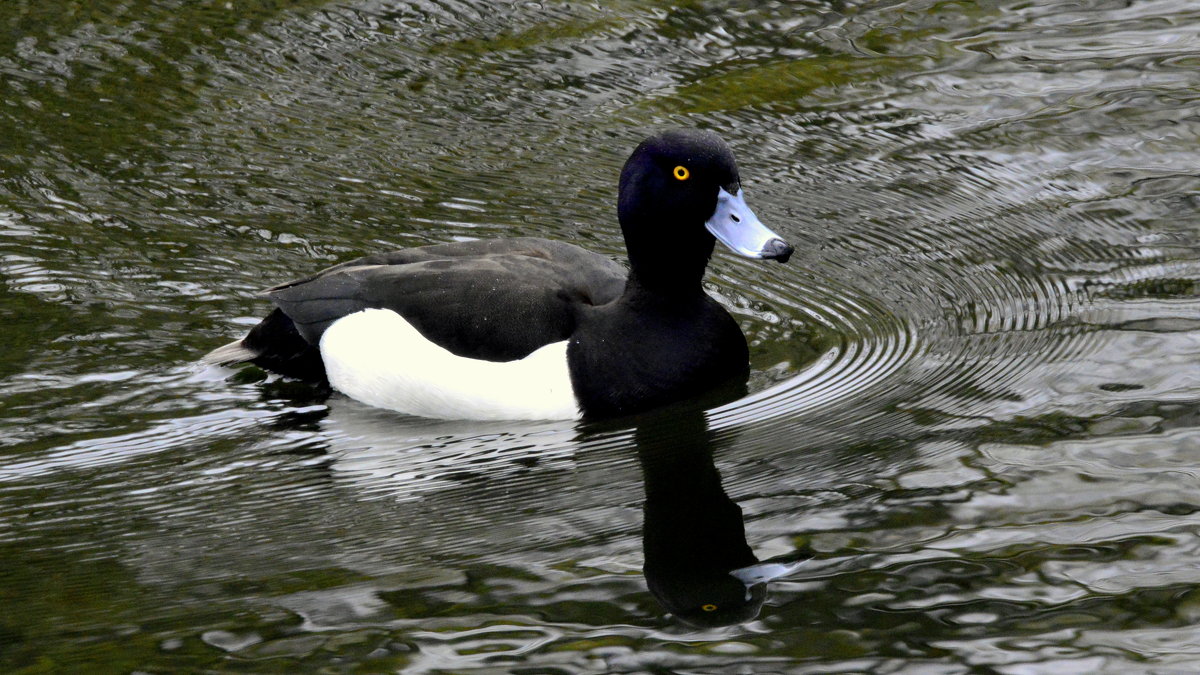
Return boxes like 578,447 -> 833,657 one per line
320,310 -> 580,419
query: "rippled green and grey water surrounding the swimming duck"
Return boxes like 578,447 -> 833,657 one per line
0,0 -> 1200,675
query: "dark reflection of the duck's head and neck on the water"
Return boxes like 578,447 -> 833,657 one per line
636,403 -> 808,627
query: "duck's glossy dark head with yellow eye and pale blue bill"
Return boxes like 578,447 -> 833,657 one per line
618,129 -> 793,281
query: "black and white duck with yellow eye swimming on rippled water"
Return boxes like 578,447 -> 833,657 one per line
204,129 -> 793,420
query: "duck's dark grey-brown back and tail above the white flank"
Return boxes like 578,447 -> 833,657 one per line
212,238 -> 625,381
